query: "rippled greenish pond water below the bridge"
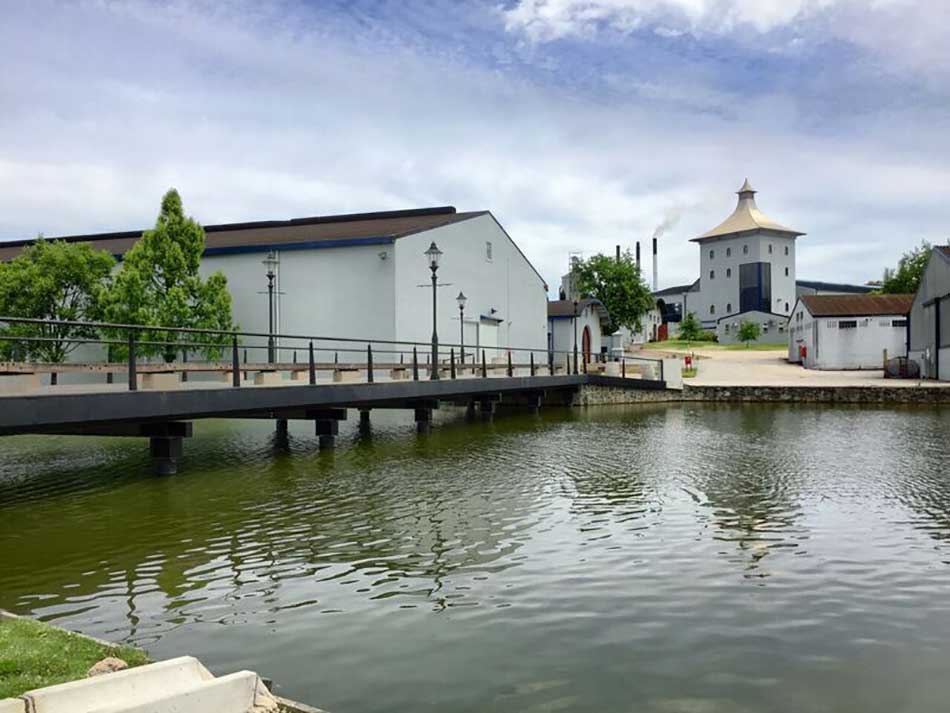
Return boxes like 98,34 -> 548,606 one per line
0,404 -> 950,713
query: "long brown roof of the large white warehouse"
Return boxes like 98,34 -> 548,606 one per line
0,206 -> 488,260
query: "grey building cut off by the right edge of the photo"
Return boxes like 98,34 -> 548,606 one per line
908,245 -> 950,381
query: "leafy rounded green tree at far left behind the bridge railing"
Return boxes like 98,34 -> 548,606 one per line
0,236 -> 115,363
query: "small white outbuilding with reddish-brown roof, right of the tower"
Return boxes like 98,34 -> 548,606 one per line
786,294 -> 914,369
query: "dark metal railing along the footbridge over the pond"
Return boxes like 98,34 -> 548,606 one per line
0,316 -> 663,391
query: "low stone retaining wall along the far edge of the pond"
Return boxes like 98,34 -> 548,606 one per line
574,384 -> 950,406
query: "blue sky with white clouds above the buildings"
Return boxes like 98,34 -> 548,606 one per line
0,0 -> 950,293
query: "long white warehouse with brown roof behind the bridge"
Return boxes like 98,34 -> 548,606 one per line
0,207 -> 548,361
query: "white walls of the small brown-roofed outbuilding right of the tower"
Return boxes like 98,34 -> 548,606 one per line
788,302 -> 907,369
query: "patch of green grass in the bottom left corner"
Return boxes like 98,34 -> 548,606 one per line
0,617 -> 148,698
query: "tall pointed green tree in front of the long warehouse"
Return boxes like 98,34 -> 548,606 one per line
104,188 -> 235,361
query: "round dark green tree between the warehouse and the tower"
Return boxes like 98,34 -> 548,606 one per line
571,250 -> 656,334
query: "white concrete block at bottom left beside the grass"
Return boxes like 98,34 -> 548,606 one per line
23,656 -> 214,713
